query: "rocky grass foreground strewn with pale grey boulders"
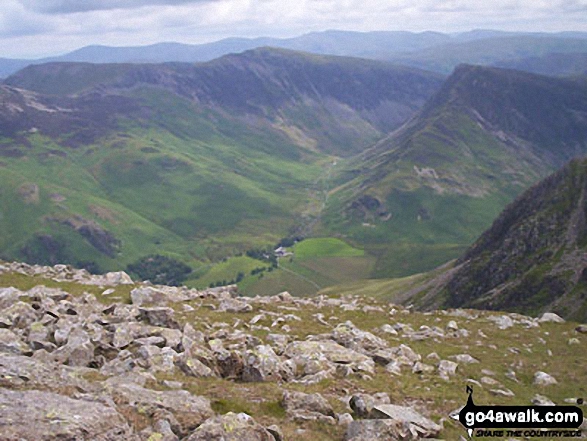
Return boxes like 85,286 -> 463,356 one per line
0,263 -> 587,441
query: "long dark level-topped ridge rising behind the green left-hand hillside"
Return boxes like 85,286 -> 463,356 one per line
5,48 -> 442,154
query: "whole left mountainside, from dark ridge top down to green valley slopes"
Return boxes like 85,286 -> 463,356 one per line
0,49 -> 442,270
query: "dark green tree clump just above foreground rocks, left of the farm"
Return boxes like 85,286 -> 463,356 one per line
126,254 -> 192,286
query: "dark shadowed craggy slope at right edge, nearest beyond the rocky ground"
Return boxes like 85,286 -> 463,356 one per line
444,159 -> 587,320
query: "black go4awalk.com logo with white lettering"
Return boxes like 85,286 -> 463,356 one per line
454,386 -> 583,438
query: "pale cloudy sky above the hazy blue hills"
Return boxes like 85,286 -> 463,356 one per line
0,0 -> 587,58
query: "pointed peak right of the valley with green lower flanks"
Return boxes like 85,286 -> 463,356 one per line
323,66 -> 587,277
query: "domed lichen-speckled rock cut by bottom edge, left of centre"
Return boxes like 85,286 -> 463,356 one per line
185,412 -> 276,441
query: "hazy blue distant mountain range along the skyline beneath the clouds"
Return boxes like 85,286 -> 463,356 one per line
0,30 -> 587,77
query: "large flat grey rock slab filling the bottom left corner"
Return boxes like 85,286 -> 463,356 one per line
0,388 -> 138,441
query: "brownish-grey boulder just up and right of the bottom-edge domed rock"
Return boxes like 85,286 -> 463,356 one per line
281,390 -> 336,424
